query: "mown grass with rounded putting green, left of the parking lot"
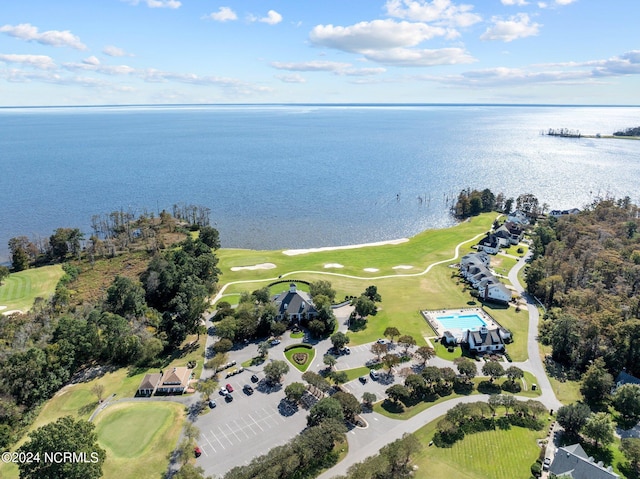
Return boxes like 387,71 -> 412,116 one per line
95,402 -> 184,479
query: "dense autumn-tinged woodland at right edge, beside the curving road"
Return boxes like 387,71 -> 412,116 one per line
527,198 -> 640,376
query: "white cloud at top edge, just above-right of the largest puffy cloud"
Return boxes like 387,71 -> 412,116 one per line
385,0 -> 482,27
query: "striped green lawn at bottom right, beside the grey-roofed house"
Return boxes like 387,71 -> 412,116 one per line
414,418 -> 544,479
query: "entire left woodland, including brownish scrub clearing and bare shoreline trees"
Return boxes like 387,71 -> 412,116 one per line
0,207 -> 220,448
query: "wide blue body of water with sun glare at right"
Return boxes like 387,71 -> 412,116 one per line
0,105 -> 640,261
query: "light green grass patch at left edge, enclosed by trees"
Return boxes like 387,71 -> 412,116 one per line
0,265 -> 64,313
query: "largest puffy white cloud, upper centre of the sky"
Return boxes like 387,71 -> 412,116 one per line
309,19 -> 447,53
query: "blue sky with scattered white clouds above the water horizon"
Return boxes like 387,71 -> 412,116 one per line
0,0 -> 640,106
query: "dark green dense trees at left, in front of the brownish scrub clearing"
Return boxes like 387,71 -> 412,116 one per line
0,214 -> 220,447
